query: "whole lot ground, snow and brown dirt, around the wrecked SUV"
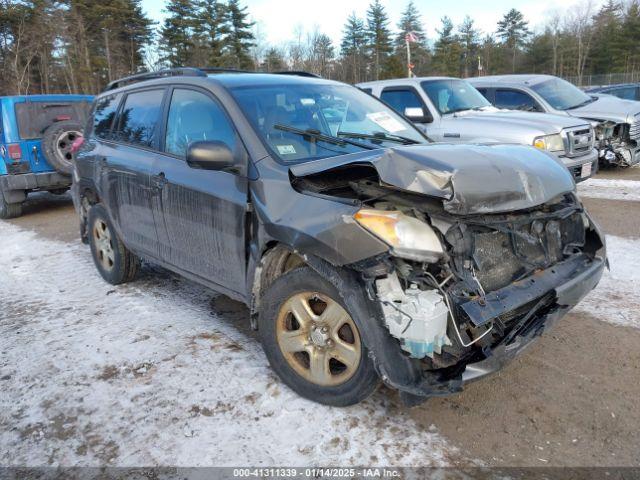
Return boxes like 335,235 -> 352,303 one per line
0,169 -> 640,466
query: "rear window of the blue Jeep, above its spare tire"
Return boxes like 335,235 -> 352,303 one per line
15,101 -> 91,140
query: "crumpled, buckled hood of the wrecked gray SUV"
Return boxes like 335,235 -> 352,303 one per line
290,144 -> 575,215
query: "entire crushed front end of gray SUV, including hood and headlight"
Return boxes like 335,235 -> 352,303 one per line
291,145 -> 607,404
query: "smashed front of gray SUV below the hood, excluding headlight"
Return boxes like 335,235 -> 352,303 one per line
355,189 -> 606,403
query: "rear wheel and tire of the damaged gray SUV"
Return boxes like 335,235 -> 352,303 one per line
87,204 -> 140,285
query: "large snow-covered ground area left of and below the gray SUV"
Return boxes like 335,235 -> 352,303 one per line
0,222 -> 459,466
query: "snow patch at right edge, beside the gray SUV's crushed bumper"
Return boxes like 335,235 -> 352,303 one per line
576,235 -> 640,328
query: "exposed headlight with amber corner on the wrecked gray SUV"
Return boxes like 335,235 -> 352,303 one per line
354,208 -> 444,262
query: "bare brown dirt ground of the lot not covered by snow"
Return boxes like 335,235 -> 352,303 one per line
3,168 -> 640,466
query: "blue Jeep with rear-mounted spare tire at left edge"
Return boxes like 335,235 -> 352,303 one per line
0,95 -> 93,218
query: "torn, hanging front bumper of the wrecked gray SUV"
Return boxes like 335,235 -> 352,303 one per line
383,254 -> 606,405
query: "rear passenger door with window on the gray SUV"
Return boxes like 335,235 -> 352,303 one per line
103,88 -> 166,258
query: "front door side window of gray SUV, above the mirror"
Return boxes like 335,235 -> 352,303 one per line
165,89 -> 236,157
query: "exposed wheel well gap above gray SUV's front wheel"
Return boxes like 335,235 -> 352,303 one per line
251,243 -> 306,315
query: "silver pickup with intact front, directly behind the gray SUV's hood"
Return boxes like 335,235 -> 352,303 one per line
357,77 -> 598,182
